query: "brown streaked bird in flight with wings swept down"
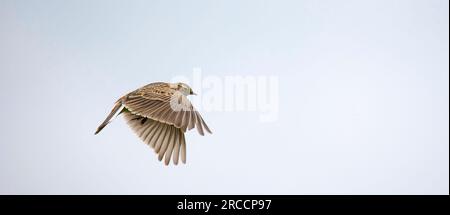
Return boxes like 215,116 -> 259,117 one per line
95,82 -> 212,165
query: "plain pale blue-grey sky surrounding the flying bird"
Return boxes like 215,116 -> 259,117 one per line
0,0 -> 449,194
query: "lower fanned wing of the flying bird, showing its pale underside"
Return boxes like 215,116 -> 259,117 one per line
123,112 -> 186,165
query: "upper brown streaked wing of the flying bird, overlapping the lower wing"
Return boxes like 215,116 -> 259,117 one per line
123,83 -> 212,134
